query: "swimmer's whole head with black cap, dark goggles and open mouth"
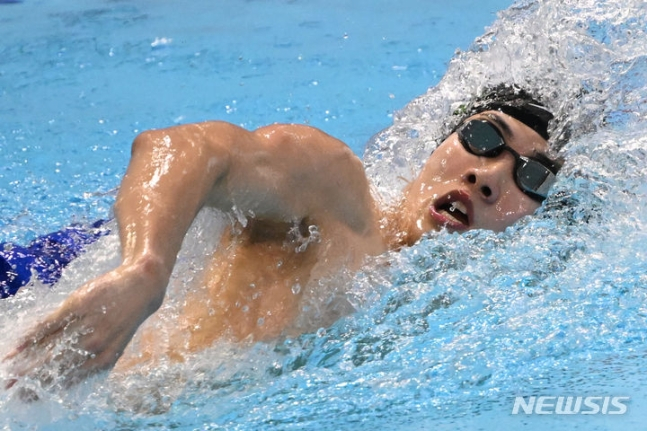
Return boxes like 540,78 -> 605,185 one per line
402,86 -> 561,243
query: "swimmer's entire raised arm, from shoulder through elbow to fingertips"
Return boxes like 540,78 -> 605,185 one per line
2,122 -> 378,381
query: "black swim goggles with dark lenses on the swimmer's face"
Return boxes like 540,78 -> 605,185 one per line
457,120 -> 557,202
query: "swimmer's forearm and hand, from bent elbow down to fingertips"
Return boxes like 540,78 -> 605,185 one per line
4,121 -> 246,386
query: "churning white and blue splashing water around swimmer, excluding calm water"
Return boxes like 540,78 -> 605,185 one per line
0,0 -> 647,430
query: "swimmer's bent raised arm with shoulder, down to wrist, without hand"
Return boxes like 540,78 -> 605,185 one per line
104,122 -> 372,304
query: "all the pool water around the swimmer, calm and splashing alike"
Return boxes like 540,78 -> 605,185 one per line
0,0 -> 647,431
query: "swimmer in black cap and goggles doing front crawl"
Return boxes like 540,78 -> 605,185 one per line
5,86 -> 561,387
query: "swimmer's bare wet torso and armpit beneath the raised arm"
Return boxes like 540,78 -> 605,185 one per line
117,126 -> 384,369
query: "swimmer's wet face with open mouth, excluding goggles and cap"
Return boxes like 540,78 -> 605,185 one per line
403,111 -> 548,241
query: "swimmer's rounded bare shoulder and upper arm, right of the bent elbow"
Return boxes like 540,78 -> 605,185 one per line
207,123 -> 375,233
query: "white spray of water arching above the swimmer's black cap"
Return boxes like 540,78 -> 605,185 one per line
364,1 -> 647,201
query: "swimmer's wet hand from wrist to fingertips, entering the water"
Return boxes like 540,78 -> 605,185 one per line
4,267 -> 166,389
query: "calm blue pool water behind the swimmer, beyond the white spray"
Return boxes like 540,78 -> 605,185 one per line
0,0 -> 510,241
